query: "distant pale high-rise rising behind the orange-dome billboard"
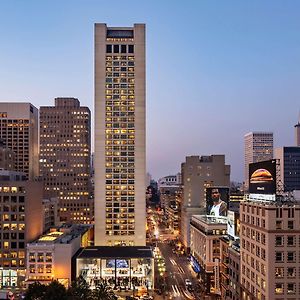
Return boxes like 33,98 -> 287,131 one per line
244,132 -> 273,189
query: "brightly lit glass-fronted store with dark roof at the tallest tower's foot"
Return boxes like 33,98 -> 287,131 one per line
73,246 -> 154,290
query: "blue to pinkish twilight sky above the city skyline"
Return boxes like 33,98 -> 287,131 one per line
0,0 -> 300,181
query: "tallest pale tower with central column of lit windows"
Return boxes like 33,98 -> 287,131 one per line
94,24 -> 146,246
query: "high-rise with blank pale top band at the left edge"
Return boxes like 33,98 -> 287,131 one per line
0,103 -> 39,179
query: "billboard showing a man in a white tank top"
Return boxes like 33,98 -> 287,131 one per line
206,186 -> 229,217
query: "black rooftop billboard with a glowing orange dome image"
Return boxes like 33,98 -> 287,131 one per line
249,159 -> 276,194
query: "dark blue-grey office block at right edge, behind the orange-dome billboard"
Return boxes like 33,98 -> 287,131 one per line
274,147 -> 300,192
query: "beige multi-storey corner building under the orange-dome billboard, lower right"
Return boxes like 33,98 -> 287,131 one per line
240,201 -> 300,300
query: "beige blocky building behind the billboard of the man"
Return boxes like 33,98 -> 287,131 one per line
181,155 -> 230,249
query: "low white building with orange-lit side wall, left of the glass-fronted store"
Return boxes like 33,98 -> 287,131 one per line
26,224 -> 93,286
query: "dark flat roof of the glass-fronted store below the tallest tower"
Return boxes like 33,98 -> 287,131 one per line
76,246 -> 154,258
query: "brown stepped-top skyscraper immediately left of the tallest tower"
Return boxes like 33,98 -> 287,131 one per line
40,98 -> 93,223
